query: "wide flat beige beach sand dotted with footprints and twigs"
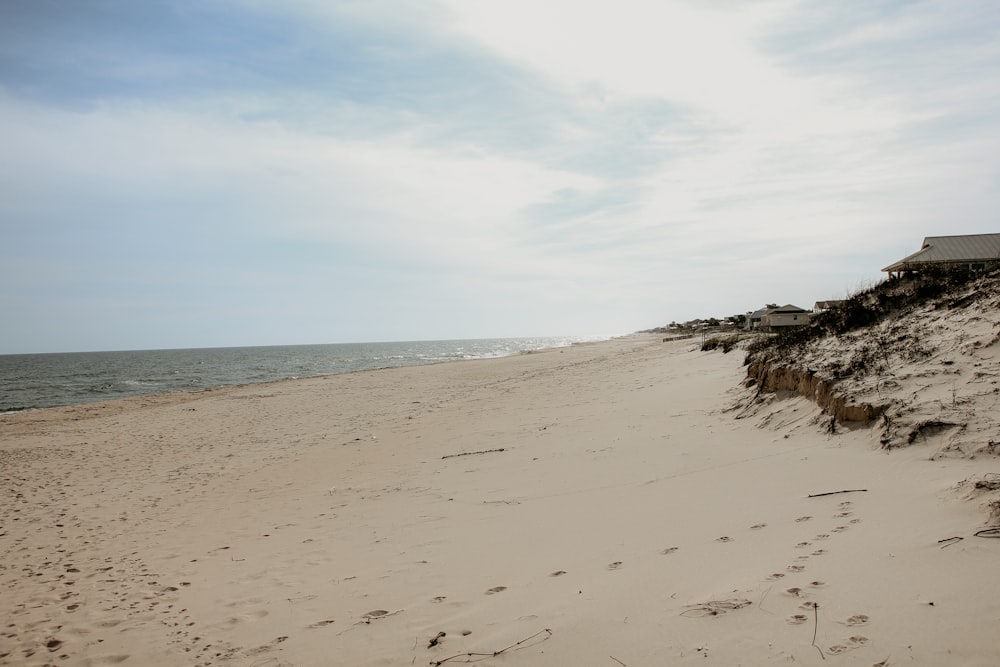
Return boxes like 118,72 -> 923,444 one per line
0,336 -> 1000,667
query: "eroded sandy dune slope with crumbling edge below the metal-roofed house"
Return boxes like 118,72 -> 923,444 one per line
741,270 -> 1000,456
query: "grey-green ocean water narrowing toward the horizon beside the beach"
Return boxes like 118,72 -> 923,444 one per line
0,337 -> 600,413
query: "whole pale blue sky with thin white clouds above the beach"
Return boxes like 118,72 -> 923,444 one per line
0,0 -> 1000,354
